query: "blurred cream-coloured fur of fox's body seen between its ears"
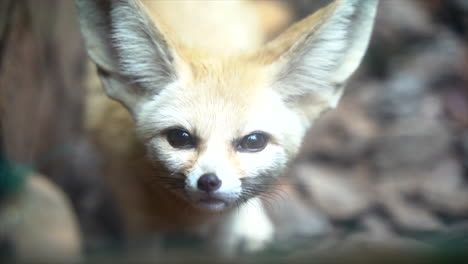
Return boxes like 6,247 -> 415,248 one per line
143,0 -> 265,54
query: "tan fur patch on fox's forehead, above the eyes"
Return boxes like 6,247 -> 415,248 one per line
156,53 -> 271,130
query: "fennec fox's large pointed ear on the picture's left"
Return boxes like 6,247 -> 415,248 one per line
76,0 -> 183,112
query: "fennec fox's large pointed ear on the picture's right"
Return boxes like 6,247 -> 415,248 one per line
260,0 -> 378,115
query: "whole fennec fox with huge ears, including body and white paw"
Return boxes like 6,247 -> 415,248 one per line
77,0 -> 378,252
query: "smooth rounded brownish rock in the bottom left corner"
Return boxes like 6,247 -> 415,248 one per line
0,175 -> 81,263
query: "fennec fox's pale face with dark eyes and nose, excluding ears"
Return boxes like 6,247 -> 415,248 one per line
135,58 -> 306,210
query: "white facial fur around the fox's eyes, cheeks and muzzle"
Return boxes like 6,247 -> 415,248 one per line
136,85 -> 306,211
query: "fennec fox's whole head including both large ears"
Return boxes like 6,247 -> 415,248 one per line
77,0 -> 378,211
